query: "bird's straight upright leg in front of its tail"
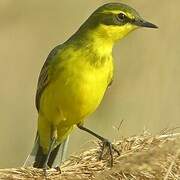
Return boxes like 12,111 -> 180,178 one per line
43,130 -> 57,176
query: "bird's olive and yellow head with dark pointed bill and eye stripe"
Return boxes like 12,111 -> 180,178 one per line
81,3 -> 157,41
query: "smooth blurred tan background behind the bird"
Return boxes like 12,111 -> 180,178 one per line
0,0 -> 180,168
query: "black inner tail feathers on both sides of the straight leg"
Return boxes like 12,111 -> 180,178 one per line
33,144 -> 60,168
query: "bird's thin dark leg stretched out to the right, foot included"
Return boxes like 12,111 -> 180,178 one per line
77,124 -> 120,167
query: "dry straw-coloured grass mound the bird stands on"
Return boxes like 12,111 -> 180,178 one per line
0,132 -> 180,180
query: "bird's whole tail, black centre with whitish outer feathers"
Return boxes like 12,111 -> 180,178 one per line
24,134 -> 69,168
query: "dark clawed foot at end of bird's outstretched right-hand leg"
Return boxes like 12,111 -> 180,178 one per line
99,139 -> 121,167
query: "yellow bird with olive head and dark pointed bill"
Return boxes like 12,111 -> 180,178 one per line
25,3 -> 158,170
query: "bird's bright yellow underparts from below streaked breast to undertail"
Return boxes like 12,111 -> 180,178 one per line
38,53 -> 113,151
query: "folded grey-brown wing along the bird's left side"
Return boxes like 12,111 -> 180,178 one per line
36,45 -> 61,111
